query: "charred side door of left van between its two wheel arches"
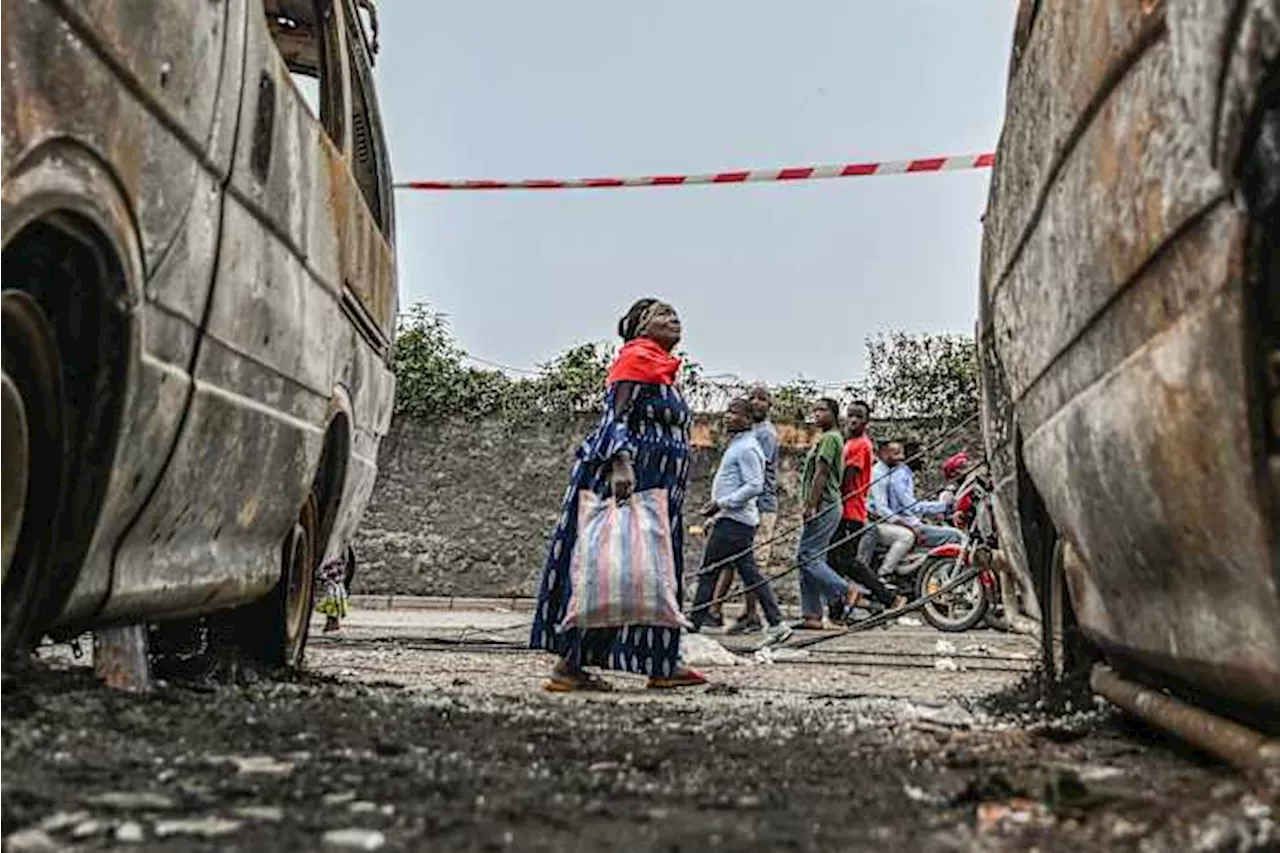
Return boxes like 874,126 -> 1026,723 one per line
104,3 -> 330,619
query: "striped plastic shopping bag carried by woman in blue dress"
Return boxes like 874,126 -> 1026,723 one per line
559,489 -> 690,631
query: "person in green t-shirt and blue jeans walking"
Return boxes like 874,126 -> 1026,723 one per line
796,397 -> 861,630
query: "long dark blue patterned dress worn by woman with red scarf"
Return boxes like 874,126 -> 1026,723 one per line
530,382 -> 691,678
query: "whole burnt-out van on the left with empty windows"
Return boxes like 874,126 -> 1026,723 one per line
0,0 -> 397,663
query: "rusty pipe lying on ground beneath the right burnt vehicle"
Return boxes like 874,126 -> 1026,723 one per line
1089,663 -> 1280,776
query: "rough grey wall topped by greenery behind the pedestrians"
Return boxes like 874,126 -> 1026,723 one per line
355,416 -> 977,598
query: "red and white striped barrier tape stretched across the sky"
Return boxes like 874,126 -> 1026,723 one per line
394,154 -> 996,191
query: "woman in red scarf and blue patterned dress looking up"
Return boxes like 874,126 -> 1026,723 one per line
530,298 -> 705,693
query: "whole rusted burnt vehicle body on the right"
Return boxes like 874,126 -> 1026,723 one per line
979,0 -> 1280,724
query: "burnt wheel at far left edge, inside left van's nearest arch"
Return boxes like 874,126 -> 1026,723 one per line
0,289 -> 64,665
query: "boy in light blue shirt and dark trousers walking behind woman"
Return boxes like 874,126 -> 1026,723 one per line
692,397 -> 791,643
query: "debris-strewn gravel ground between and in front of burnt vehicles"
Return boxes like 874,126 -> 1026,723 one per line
0,613 -> 1276,852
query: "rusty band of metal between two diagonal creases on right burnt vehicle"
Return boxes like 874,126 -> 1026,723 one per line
993,36 -> 1225,402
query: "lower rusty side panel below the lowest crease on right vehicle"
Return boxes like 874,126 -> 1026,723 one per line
1027,287 -> 1280,707
